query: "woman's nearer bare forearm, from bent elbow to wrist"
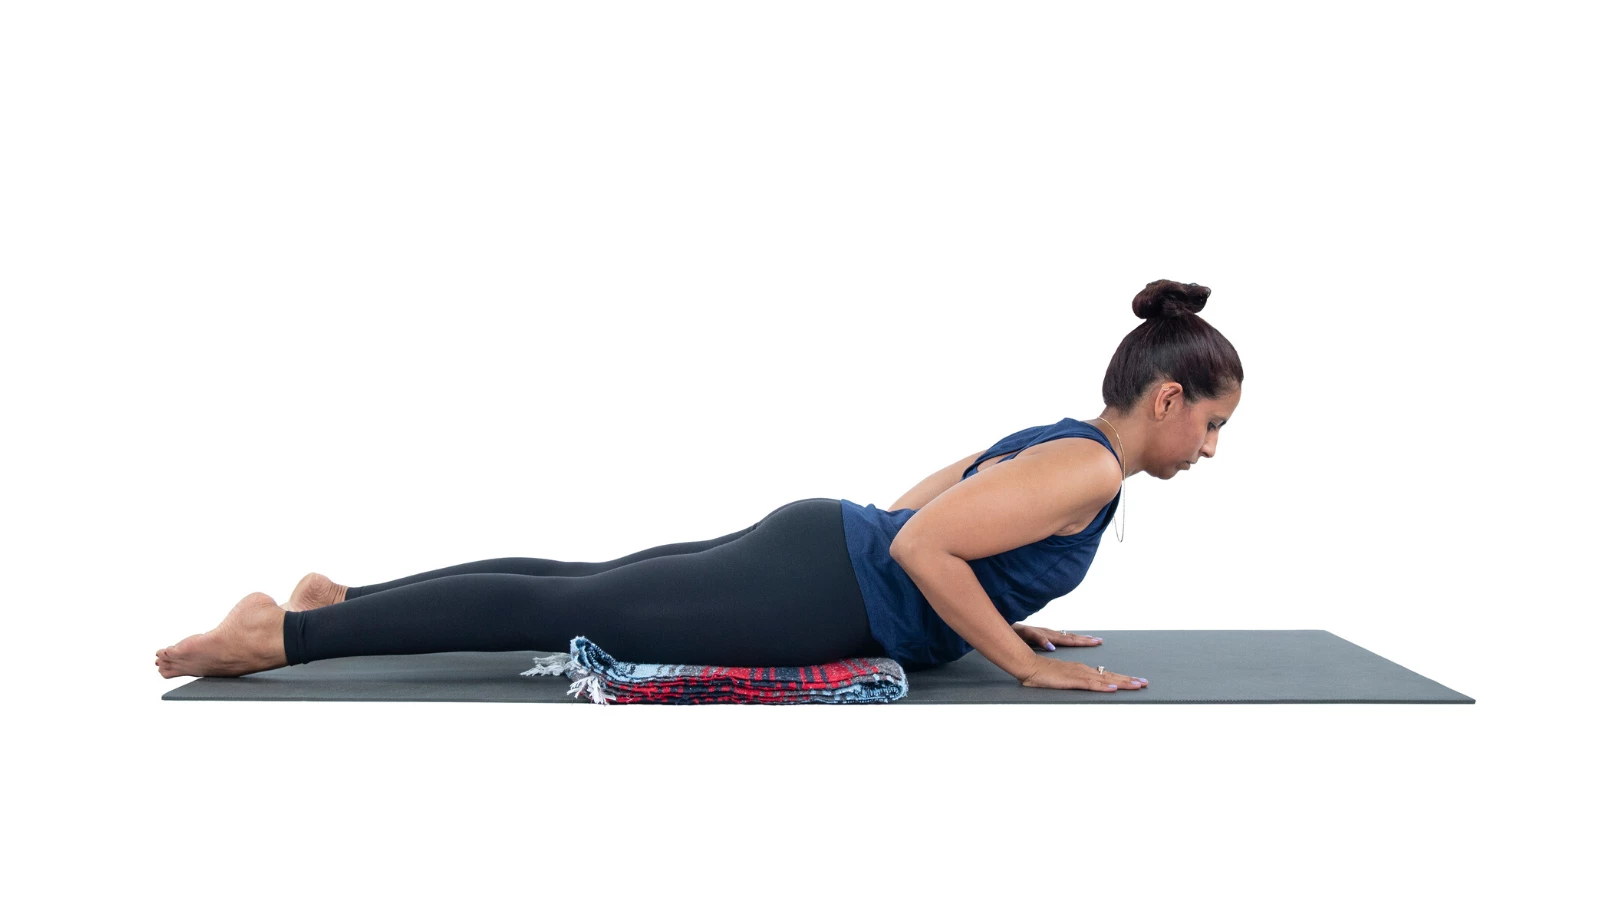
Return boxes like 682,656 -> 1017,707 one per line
894,549 -> 1038,681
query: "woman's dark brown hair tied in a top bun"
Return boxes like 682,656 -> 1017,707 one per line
1101,279 -> 1245,415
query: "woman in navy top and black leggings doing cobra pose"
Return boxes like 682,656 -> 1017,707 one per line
155,280 -> 1245,690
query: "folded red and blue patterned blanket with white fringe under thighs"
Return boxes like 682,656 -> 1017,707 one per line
522,636 -> 909,703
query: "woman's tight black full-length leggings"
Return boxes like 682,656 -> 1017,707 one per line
283,498 -> 885,666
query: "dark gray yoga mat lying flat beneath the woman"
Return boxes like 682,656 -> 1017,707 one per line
162,629 -> 1475,705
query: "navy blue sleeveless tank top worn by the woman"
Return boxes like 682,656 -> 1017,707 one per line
840,418 -> 1122,671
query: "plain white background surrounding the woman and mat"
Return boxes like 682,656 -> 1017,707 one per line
0,0 -> 1597,897
